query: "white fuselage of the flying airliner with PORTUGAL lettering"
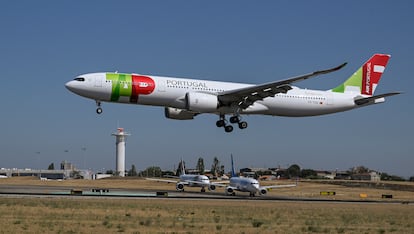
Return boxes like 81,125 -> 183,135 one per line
66,73 -> 357,117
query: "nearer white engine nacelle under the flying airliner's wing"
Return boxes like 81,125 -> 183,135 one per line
185,92 -> 218,112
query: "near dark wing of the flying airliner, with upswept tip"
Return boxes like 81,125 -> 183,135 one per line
217,63 -> 347,109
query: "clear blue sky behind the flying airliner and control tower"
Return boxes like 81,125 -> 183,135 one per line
0,1 -> 414,177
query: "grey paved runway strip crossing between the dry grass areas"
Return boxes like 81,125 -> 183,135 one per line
0,184 -> 414,205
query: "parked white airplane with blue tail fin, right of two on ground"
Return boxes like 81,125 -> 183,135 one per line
219,155 -> 297,197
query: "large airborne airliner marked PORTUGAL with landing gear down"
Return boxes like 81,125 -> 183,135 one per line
65,54 -> 399,132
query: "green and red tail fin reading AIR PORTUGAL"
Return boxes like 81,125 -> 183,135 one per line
331,54 -> 391,96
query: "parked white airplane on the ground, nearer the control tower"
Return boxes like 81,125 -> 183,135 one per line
146,161 -> 216,192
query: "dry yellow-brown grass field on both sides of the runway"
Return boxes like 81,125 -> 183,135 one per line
0,179 -> 414,233
